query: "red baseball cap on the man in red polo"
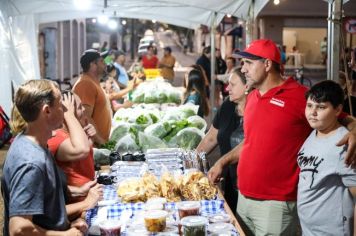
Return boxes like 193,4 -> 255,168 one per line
233,39 -> 281,64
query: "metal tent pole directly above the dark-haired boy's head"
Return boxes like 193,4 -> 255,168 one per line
327,0 -> 342,81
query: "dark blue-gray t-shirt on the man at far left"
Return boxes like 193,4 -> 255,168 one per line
1,134 -> 69,235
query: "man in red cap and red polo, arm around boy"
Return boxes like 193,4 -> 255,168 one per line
208,39 -> 356,235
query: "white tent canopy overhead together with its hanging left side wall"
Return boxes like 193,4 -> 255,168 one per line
0,0 -> 268,112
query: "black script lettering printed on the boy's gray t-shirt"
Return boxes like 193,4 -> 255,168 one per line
297,149 -> 324,188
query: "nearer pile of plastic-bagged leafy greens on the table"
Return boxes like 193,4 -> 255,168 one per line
104,104 -> 207,154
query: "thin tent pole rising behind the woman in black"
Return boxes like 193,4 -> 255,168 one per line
210,12 -> 217,121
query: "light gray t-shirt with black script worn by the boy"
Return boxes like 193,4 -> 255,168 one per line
297,127 -> 356,236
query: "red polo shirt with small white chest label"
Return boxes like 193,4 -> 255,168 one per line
238,78 -> 312,201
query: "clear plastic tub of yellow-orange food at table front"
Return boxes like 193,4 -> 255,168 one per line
144,210 -> 168,232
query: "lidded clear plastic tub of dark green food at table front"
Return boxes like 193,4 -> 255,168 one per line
181,216 -> 208,236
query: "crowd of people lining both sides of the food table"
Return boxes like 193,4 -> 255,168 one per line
1,36 -> 356,235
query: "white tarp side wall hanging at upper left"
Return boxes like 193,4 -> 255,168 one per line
0,1 -> 40,115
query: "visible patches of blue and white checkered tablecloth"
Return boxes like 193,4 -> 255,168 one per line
86,185 -> 226,226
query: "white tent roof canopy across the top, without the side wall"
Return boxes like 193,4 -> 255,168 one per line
9,0 -> 268,28
